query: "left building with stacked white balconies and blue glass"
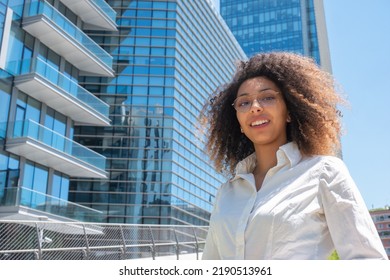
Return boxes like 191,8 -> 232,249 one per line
0,0 -> 117,221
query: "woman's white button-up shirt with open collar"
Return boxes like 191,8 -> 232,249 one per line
203,142 -> 387,260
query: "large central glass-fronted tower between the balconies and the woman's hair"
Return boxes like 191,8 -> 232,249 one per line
69,0 -> 245,225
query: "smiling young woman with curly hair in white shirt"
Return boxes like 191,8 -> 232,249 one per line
203,53 -> 387,259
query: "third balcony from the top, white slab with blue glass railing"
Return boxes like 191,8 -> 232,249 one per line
7,58 -> 110,126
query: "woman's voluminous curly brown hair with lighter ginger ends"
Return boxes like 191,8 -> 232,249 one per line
201,52 -> 344,173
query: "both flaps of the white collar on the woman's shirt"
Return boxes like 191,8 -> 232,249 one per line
232,142 -> 302,180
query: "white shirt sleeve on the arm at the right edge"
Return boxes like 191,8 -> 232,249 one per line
319,158 -> 388,260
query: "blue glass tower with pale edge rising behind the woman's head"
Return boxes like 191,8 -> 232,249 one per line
219,0 -> 331,72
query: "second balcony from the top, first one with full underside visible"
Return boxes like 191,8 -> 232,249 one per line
22,0 -> 114,77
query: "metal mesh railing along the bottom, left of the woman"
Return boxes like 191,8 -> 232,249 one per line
0,221 -> 208,260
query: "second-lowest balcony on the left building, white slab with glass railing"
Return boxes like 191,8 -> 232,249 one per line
5,120 -> 107,178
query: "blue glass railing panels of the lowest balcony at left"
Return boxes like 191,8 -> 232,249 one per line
0,187 -> 103,223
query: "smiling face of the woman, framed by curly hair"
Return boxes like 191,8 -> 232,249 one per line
234,77 -> 289,148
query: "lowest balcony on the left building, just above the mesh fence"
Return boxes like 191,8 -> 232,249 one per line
0,187 -> 104,223
